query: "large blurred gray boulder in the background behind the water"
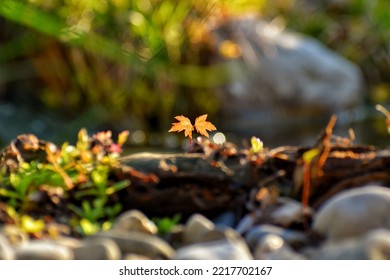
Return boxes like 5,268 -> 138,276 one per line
214,18 -> 363,144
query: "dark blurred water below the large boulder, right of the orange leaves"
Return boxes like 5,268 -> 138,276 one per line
215,104 -> 390,148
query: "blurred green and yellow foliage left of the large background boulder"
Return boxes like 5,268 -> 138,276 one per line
0,0 -> 263,137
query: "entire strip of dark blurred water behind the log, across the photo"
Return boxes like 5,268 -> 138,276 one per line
0,101 -> 390,152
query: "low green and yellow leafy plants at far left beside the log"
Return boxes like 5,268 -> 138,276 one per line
0,129 -> 130,235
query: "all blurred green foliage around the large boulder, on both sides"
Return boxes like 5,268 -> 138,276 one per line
0,0 -> 390,139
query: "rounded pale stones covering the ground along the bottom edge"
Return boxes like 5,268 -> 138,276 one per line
0,185 -> 390,260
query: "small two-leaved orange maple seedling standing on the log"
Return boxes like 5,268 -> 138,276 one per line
168,114 -> 217,143
